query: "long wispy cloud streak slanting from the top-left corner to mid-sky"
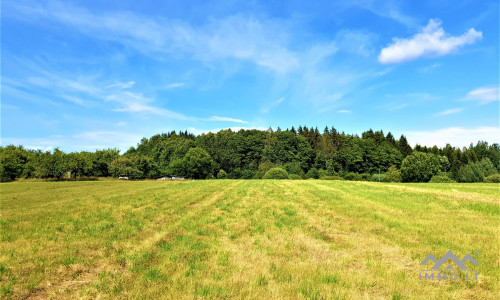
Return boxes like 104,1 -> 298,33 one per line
5,1 -> 299,73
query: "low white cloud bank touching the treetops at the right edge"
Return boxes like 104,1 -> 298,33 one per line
405,127 -> 500,147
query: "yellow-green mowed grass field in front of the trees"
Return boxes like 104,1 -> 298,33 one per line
0,180 -> 500,299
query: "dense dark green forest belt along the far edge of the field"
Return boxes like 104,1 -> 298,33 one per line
0,126 -> 500,182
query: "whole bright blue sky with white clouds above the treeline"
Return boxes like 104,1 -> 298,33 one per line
1,0 -> 500,151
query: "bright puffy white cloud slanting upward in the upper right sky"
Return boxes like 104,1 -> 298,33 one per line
378,19 -> 482,64
